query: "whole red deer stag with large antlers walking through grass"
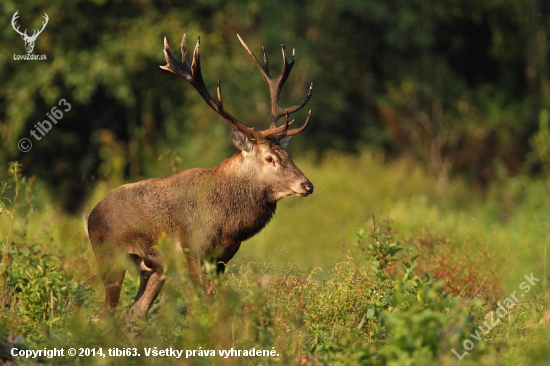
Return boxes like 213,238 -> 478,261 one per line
88,34 -> 313,318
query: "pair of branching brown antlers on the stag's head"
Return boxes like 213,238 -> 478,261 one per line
160,34 -> 313,144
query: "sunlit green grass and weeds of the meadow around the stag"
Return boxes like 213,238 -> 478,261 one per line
0,151 -> 550,365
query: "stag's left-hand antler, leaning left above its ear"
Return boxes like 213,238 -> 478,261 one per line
160,34 -> 256,136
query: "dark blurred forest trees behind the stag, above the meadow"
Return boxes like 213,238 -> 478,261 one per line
0,0 -> 550,203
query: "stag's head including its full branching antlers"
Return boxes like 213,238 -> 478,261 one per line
161,34 -> 313,201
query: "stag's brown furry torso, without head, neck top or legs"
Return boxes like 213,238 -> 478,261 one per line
89,156 -> 276,258
